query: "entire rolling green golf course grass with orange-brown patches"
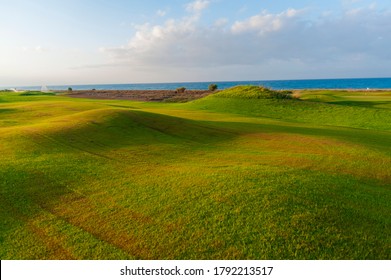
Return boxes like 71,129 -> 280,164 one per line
0,87 -> 391,259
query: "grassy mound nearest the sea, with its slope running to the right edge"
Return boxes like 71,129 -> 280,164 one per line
191,86 -> 391,131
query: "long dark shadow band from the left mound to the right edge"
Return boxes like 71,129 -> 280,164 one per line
16,106 -> 391,162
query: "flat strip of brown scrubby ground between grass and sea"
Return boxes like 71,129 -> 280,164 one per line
64,90 -> 217,102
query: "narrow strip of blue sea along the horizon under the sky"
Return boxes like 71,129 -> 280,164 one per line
6,78 -> 391,90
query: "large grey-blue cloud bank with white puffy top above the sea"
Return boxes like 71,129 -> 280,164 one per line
100,5 -> 391,80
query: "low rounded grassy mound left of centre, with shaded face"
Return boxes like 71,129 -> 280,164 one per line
25,109 -> 234,153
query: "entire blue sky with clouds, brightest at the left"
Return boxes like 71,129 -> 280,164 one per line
0,0 -> 391,87
